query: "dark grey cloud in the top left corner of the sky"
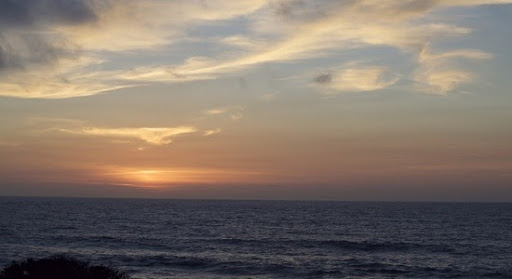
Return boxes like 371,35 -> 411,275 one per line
0,0 -> 101,74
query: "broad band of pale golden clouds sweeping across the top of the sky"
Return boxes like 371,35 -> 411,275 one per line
0,0 -> 512,98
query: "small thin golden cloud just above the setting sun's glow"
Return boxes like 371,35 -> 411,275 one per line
58,126 -> 197,145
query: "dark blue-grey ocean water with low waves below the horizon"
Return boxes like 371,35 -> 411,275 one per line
0,198 -> 512,278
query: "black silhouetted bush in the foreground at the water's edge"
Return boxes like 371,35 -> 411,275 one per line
0,256 -> 130,279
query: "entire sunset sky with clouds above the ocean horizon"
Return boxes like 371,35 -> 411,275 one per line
0,0 -> 512,202
